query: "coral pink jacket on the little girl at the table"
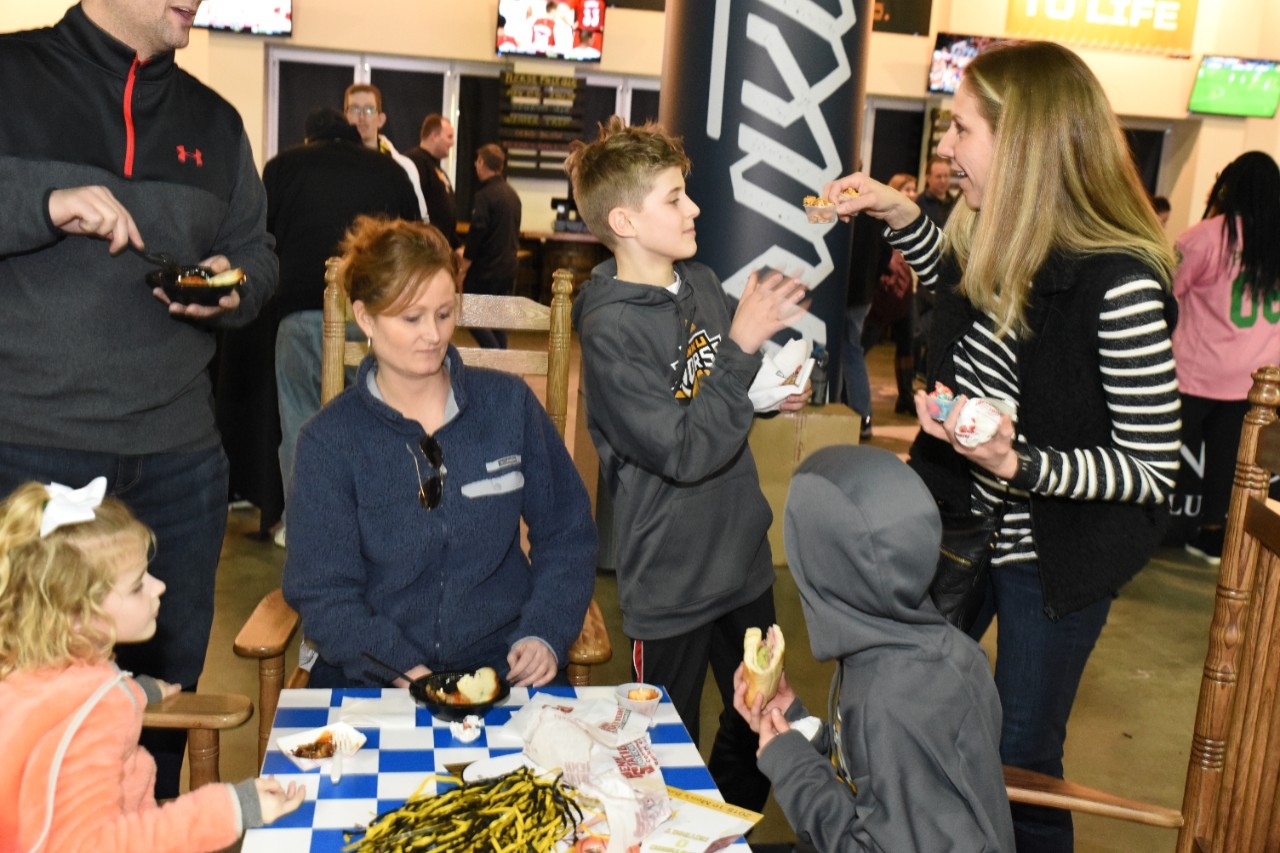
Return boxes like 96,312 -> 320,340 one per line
0,662 -> 242,853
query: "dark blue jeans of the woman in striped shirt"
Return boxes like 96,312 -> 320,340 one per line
969,562 -> 1111,853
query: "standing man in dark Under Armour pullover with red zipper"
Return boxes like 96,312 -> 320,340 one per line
0,0 -> 276,797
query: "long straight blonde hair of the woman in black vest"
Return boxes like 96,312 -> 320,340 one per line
947,42 -> 1174,334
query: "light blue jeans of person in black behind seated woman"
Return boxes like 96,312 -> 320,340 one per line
275,311 -> 324,494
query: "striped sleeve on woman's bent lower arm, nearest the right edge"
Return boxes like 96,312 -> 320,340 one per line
1013,279 -> 1181,503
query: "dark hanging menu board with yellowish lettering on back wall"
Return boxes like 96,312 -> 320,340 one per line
498,72 -> 585,178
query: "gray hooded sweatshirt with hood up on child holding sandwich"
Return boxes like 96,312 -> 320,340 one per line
759,447 -> 1014,853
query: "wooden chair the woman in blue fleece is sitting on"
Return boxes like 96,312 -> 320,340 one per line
234,257 -> 613,761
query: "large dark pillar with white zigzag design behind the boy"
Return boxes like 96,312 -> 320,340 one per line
659,0 -> 872,392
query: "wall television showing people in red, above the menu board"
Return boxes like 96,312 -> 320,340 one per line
494,0 -> 605,63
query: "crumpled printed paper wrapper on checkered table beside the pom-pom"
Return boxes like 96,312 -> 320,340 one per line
508,693 -> 671,853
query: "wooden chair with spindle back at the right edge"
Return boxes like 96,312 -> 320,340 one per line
1005,366 -> 1280,853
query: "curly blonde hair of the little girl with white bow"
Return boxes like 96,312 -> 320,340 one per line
0,483 -> 155,679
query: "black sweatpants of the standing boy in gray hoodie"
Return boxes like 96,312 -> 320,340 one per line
631,588 -> 777,812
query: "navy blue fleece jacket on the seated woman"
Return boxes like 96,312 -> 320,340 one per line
283,347 -> 596,684
